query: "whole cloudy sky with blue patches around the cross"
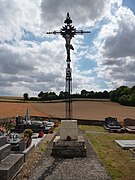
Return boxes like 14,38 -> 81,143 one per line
0,0 -> 135,96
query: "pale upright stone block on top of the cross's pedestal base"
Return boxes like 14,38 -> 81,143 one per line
60,120 -> 78,140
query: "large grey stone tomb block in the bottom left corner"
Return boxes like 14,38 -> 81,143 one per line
0,154 -> 24,180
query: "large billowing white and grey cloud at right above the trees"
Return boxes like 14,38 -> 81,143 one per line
95,7 -> 135,88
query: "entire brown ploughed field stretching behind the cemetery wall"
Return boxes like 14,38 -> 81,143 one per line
0,101 -> 135,121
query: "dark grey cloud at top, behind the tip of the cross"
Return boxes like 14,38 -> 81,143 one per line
41,0 -> 111,31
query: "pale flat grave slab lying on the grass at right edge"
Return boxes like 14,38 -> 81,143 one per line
115,140 -> 135,149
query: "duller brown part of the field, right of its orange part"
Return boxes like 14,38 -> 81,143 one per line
33,101 -> 135,121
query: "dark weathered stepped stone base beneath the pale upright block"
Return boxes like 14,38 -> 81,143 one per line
51,136 -> 86,158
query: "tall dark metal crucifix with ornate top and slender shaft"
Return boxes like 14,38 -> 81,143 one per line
47,13 -> 90,119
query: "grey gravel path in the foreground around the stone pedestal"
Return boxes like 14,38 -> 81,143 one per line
29,130 -> 111,180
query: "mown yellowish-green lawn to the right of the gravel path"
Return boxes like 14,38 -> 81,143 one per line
81,126 -> 135,180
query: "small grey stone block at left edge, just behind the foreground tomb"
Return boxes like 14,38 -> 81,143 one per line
0,144 -> 11,161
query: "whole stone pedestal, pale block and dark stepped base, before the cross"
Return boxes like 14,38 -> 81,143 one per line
52,120 -> 86,158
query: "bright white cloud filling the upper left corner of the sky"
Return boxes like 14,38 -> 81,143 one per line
0,0 -> 40,41
